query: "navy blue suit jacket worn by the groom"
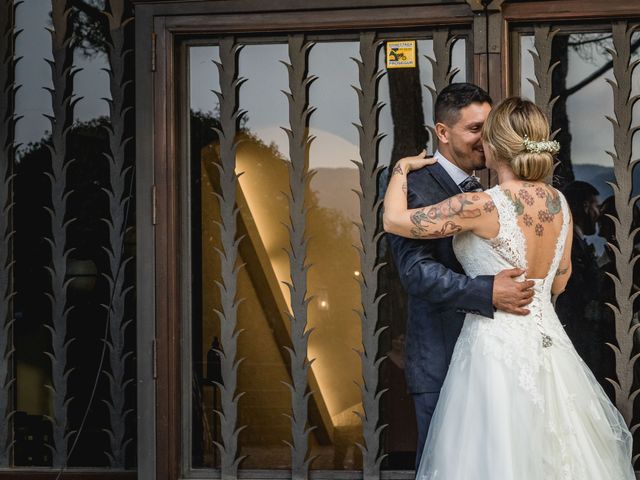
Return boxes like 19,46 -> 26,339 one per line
387,163 -> 493,394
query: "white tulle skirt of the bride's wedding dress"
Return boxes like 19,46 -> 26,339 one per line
416,311 -> 635,480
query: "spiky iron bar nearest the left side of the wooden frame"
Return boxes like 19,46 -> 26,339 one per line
104,0 -> 134,469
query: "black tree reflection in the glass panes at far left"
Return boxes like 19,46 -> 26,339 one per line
14,117 -> 135,466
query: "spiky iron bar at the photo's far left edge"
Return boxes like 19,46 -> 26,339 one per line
0,0 -> 21,468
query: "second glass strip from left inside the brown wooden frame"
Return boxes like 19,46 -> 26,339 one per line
236,44 -> 291,469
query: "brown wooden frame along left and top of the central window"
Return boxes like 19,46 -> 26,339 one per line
136,1 -> 473,479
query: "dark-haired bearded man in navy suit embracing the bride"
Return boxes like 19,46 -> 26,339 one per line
387,83 -> 533,468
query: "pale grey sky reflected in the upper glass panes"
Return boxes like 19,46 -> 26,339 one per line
16,0 -> 640,172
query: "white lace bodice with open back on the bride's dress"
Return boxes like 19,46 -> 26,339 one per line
452,186 -> 572,408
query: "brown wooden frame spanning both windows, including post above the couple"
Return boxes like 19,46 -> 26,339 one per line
134,0 -> 639,480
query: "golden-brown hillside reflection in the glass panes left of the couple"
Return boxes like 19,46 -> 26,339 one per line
199,126 -> 361,468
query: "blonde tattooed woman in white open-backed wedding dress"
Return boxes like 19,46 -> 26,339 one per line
383,97 -> 635,480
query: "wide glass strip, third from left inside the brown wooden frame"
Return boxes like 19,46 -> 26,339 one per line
308,42 -> 363,470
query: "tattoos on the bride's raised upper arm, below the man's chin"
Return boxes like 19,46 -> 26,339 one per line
410,195 -> 482,238
